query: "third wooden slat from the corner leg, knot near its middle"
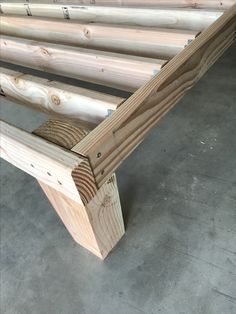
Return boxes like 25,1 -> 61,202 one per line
1,15 -> 197,58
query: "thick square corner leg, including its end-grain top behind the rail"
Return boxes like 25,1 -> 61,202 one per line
34,121 -> 125,259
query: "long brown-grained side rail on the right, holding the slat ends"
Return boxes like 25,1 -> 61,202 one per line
73,4 -> 236,186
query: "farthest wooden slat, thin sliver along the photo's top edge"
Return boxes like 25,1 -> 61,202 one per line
1,0 -> 232,9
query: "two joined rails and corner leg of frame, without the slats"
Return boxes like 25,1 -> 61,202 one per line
0,4 -> 236,259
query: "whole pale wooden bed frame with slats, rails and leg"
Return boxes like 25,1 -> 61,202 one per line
0,0 -> 236,259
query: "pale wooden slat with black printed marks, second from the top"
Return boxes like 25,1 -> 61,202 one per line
1,3 -> 222,31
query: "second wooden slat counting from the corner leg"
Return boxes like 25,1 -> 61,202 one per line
0,36 -> 165,91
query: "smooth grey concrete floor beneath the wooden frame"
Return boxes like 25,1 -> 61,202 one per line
1,45 -> 236,314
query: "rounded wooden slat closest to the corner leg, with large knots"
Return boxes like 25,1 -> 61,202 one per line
0,67 -> 124,128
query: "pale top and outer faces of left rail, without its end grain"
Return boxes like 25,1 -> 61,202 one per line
0,121 -> 83,204
